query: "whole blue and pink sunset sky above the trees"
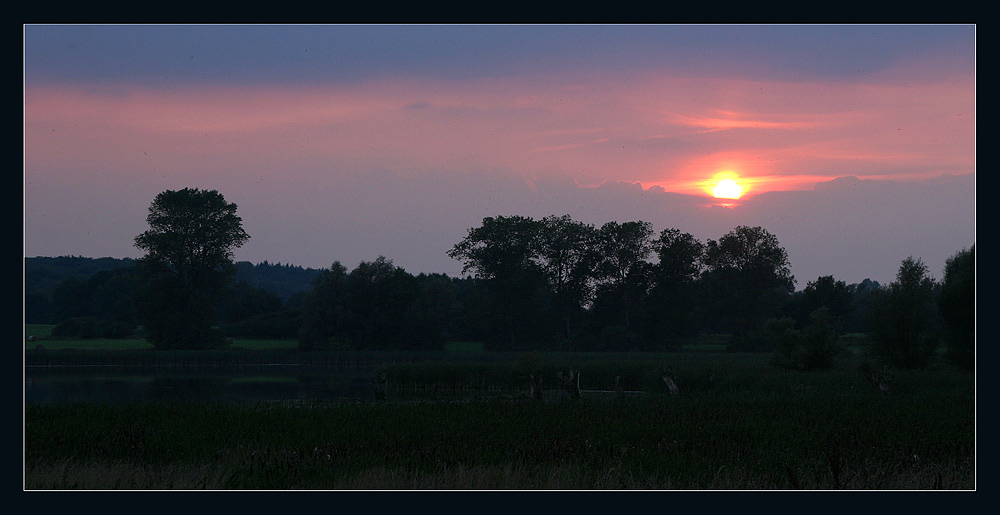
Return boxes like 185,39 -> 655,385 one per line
23,25 -> 976,289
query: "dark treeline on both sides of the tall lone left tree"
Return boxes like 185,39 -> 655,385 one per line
25,216 -> 975,366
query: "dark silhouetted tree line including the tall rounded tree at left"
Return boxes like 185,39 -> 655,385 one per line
27,189 -> 975,368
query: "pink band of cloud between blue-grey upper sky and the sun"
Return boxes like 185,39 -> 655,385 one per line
25,67 -> 975,198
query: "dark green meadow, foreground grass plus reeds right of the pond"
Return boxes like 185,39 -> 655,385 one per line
24,326 -> 976,490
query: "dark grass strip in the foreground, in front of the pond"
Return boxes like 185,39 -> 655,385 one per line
25,376 -> 975,490
